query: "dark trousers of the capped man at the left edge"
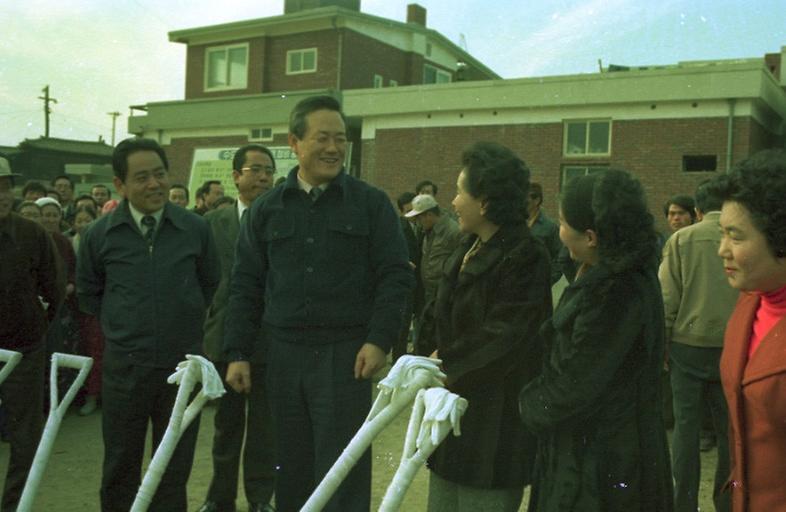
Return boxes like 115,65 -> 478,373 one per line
0,343 -> 46,511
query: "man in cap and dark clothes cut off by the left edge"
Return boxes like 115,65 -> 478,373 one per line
0,157 -> 65,510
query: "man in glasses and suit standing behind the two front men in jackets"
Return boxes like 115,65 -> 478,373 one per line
199,144 -> 276,512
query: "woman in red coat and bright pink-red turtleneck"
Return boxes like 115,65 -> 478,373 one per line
718,150 -> 786,512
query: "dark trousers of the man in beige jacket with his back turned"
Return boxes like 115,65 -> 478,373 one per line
669,343 -> 730,512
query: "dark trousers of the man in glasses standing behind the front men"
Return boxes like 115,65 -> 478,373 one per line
207,363 -> 276,510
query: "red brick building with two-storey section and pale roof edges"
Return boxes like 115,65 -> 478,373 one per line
129,0 -> 786,231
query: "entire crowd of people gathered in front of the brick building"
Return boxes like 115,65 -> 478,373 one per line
0,96 -> 786,512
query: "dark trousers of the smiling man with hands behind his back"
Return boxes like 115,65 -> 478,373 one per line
101,358 -> 199,512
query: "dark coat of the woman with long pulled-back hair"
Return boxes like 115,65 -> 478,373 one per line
520,258 -> 673,512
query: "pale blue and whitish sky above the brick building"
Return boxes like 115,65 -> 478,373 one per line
0,0 -> 786,146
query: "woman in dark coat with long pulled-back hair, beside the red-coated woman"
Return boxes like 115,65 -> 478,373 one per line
520,170 -> 672,512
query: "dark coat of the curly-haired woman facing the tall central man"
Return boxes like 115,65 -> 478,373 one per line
422,225 -> 551,489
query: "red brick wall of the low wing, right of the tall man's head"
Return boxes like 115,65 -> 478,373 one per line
363,118 -> 773,230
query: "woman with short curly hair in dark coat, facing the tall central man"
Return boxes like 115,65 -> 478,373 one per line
428,143 -> 551,512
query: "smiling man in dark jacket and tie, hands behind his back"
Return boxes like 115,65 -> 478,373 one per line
77,138 -> 220,512
